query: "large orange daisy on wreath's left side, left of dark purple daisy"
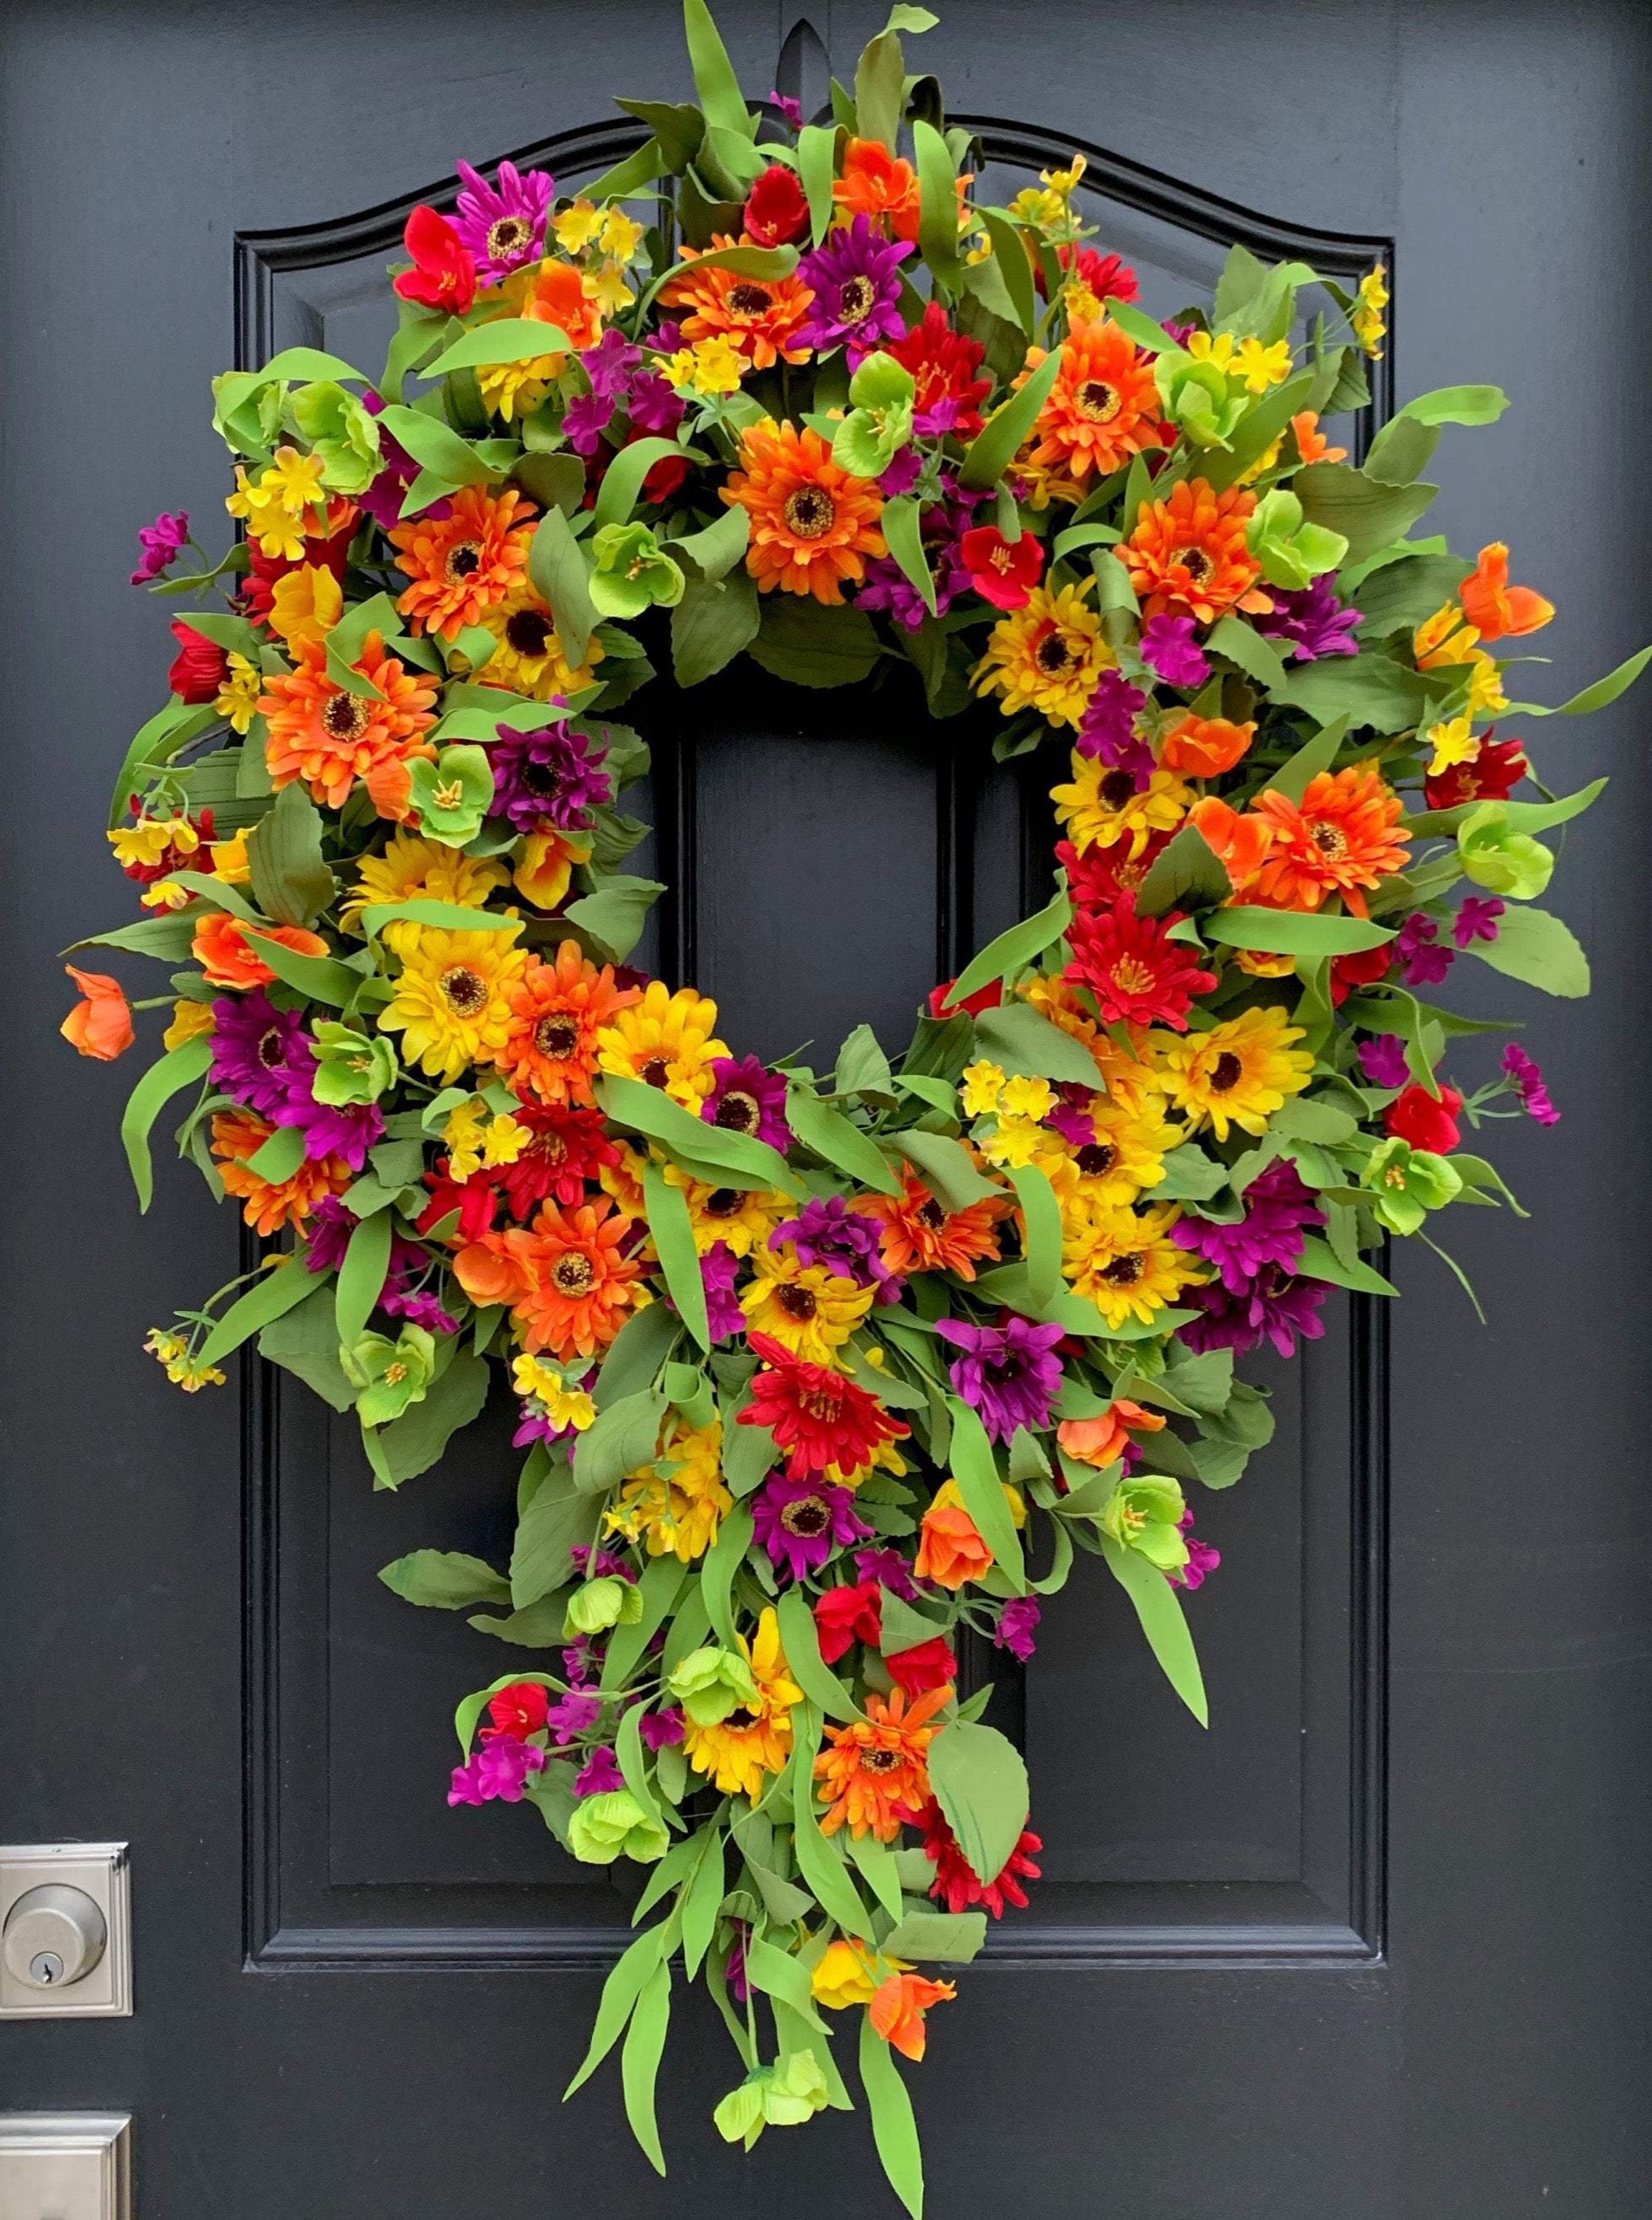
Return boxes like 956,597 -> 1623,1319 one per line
258,633 -> 436,810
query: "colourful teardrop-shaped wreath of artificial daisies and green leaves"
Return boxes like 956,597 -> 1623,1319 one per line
64,0 -> 1652,2213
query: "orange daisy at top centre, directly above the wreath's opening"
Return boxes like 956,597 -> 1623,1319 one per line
722,422 -> 888,604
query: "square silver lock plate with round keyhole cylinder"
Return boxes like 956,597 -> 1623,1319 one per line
0,1843 -> 131,2025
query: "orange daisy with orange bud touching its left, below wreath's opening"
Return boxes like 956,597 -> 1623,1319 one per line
453,1195 -> 649,1363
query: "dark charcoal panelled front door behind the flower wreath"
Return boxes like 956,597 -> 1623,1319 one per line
0,0 -> 1652,2220
